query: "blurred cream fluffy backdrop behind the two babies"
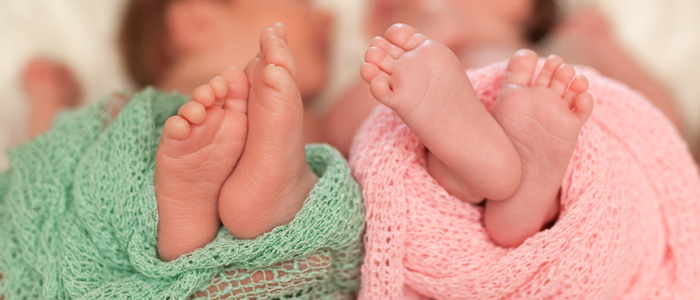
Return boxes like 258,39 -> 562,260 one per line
0,0 -> 700,170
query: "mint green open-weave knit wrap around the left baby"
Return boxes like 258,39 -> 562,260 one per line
0,89 -> 364,300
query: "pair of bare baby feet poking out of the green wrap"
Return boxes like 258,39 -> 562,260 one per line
155,24 -> 318,261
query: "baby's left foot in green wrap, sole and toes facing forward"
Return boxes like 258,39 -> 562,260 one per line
155,68 -> 248,261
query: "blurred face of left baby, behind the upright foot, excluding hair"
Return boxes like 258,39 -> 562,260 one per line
216,0 -> 332,98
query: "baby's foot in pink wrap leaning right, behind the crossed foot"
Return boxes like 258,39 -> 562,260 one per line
484,50 -> 593,247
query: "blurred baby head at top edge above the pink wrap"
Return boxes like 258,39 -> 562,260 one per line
367,0 -> 556,51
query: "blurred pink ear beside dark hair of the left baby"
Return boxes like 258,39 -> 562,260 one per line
166,0 -> 218,52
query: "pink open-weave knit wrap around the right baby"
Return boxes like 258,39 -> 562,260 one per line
350,61 -> 700,299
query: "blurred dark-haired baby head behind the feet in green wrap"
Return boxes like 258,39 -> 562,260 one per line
120,0 -> 331,98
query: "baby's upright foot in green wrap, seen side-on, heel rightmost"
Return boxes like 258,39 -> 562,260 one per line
219,23 -> 318,239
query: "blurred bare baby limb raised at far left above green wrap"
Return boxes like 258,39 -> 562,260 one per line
22,58 -> 80,138
